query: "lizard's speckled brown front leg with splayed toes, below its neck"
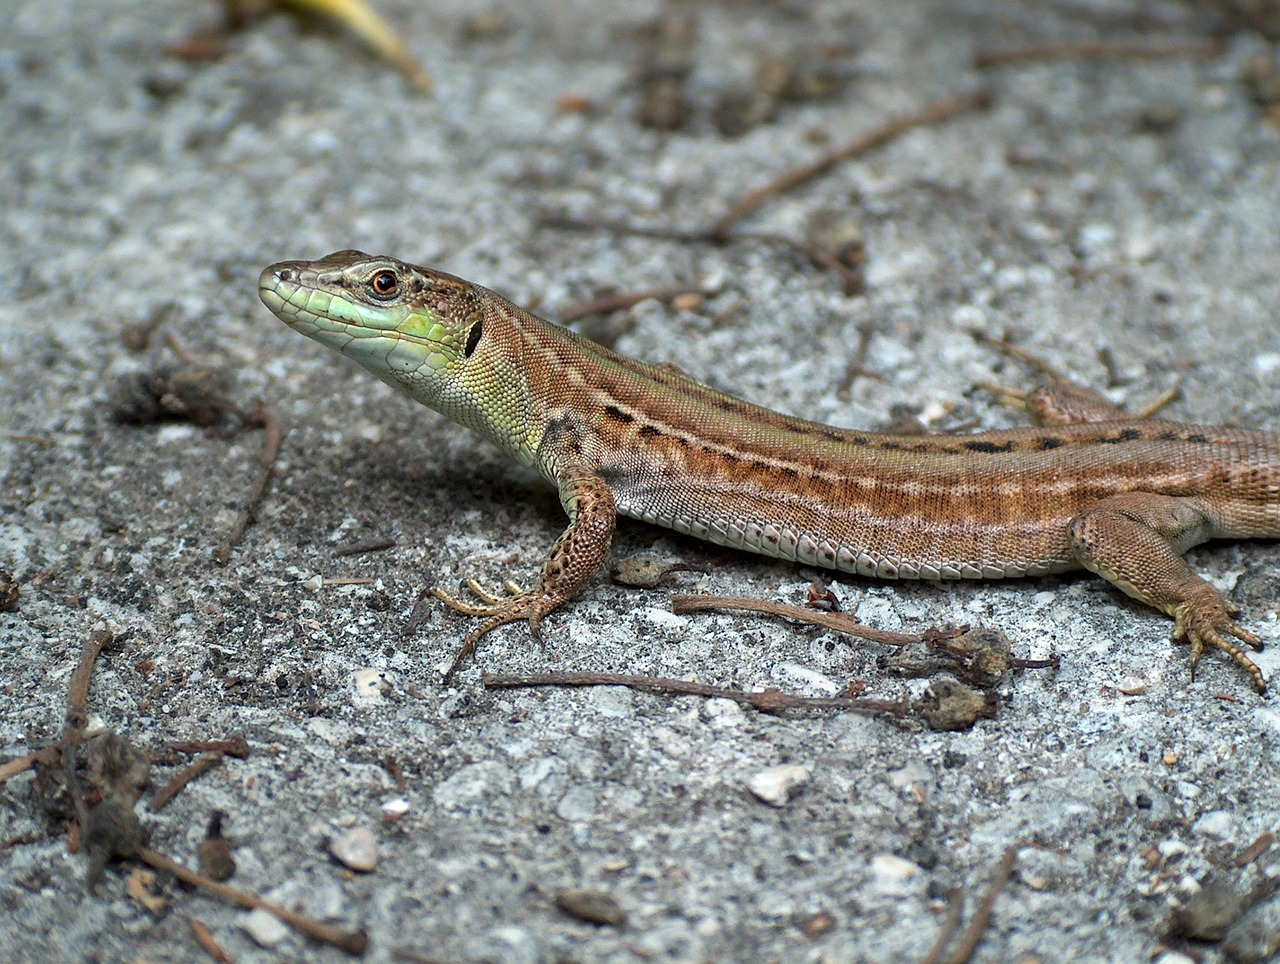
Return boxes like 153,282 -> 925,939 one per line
431,467 -> 617,680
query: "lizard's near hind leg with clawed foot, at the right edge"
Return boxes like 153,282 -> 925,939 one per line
1070,492 -> 1266,693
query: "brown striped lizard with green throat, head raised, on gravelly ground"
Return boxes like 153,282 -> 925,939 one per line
259,251 -> 1280,693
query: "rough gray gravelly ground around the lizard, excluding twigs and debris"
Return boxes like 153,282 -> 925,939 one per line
0,0 -> 1280,963
